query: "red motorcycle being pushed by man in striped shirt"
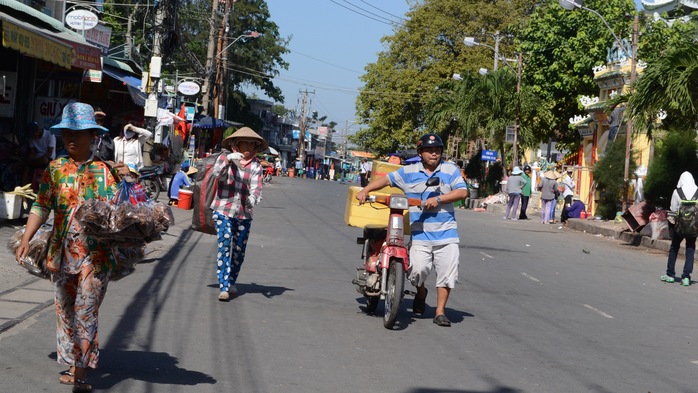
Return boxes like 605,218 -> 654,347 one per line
352,177 -> 439,329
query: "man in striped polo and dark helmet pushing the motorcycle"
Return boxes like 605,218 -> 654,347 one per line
356,134 -> 468,326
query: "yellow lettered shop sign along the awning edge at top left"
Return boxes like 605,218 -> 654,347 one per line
2,20 -> 73,69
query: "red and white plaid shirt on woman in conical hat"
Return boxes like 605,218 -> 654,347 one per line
211,150 -> 262,219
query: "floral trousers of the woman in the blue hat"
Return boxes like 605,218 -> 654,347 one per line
53,263 -> 109,368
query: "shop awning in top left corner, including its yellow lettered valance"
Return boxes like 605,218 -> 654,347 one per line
0,0 -> 102,70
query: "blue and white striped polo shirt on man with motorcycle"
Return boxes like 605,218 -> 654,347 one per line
388,161 -> 467,246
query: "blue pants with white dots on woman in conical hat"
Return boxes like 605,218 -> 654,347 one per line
213,212 -> 252,292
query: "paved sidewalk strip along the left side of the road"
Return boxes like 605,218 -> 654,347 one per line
0,197 -> 192,333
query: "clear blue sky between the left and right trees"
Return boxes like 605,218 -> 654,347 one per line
248,0 -> 641,134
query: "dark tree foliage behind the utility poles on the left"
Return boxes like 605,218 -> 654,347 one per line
98,0 -> 290,117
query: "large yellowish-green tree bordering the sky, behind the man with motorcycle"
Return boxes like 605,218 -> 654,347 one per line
351,0 -> 538,154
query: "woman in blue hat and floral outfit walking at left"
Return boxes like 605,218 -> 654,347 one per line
15,102 -> 129,393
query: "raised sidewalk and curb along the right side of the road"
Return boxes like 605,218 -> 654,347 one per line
478,199 -> 685,255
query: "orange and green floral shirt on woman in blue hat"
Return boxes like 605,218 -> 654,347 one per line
31,157 -> 118,273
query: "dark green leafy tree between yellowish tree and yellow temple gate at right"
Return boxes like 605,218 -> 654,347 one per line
516,0 -> 635,143
